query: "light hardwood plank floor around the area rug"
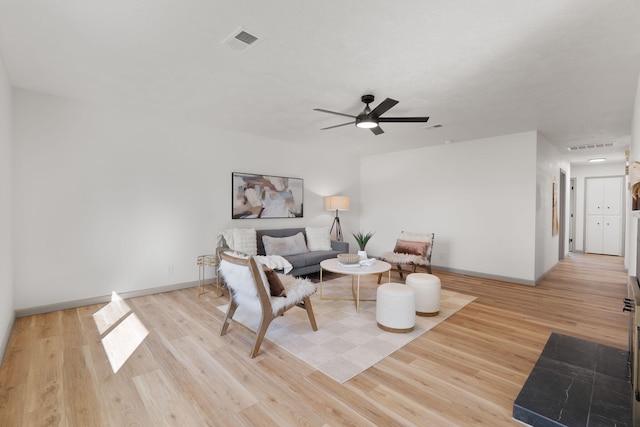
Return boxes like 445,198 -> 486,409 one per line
0,254 -> 628,427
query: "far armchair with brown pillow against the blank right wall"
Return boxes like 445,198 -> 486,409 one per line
378,231 -> 435,283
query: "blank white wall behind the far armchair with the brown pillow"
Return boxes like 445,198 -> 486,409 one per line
361,132 -> 536,284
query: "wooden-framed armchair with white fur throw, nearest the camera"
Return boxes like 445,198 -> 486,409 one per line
219,252 -> 318,357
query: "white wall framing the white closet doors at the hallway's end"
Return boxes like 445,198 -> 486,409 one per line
571,161 -> 628,252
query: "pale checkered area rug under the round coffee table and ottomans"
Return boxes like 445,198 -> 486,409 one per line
218,276 -> 475,383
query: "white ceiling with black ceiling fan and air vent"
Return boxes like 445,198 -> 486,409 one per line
0,0 -> 640,166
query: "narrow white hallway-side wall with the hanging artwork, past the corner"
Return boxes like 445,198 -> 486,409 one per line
535,133 -> 570,281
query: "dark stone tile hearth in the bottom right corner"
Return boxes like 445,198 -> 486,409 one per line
513,333 -> 632,427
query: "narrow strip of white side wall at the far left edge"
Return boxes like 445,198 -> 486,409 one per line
0,51 -> 14,361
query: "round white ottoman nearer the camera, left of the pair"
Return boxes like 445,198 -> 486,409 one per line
376,283 -> 416,333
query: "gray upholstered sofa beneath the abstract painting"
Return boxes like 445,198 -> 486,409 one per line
256,227 -> 349,276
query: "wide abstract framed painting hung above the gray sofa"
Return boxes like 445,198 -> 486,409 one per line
231,172 -> 304,219
